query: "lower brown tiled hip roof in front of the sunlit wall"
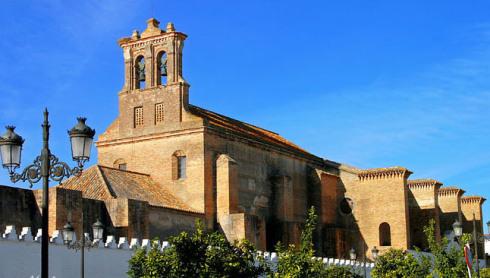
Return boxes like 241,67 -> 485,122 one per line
59,165 -> 198,213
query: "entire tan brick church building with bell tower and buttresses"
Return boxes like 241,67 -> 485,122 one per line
0,19 -> 484,258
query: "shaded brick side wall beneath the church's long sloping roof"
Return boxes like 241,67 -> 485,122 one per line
204,131 -> 321,250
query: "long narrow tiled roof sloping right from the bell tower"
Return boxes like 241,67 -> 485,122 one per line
189,105 -> 321,160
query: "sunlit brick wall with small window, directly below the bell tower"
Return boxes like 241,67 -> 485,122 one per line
98,131 -> 204,212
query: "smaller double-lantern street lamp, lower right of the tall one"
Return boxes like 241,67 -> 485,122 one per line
63,217 -> 104,278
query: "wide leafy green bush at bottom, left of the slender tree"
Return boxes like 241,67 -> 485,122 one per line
127,222 -> 267,278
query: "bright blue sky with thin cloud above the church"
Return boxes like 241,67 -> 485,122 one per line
0,0 -> 490,228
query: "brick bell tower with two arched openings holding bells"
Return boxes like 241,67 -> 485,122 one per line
99,18 -> 197,141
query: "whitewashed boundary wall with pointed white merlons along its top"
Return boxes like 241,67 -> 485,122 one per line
0,226 -> 374,278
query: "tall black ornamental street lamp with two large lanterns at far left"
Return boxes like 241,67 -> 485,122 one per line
0,109 -> 95,278
